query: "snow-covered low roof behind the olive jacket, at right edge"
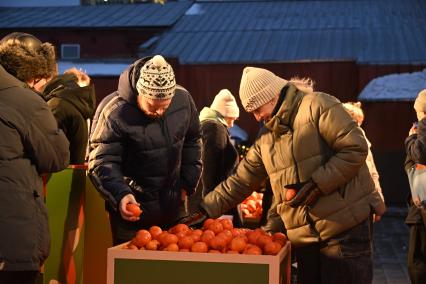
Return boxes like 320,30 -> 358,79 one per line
358,69 -> 426,101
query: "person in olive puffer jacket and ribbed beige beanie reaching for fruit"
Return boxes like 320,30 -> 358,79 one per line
182,67 -> 384,283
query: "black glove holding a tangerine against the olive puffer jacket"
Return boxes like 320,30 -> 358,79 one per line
285,180 -> 321,208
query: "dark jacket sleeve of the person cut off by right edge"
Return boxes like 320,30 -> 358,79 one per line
405,119 -> 426,164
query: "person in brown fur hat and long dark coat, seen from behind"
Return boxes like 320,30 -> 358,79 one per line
0,33 -> 69,284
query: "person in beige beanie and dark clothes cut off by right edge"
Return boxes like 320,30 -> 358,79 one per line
405,89 -> 426,284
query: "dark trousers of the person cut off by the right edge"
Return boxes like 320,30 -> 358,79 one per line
408,224 -> 426,284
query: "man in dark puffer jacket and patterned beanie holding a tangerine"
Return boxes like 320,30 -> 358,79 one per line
89,55 -> 201,244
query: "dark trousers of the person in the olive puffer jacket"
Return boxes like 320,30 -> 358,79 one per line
295,220 -> 373,284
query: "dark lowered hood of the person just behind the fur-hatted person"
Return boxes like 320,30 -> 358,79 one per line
41,74 -> 96,119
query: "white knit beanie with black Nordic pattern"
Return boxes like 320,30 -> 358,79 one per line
136,55 -> 176,100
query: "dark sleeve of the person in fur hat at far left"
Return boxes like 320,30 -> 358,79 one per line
24,95 -> 70,173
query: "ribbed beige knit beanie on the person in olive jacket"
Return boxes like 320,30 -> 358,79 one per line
240,67 -> 287,112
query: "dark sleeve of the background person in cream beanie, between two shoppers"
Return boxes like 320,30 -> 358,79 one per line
201,121 -> 227,193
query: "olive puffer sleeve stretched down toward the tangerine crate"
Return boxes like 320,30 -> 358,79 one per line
201,140 -> 267,218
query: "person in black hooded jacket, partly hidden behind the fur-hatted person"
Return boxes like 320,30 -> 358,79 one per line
42,68 -> 96,165
